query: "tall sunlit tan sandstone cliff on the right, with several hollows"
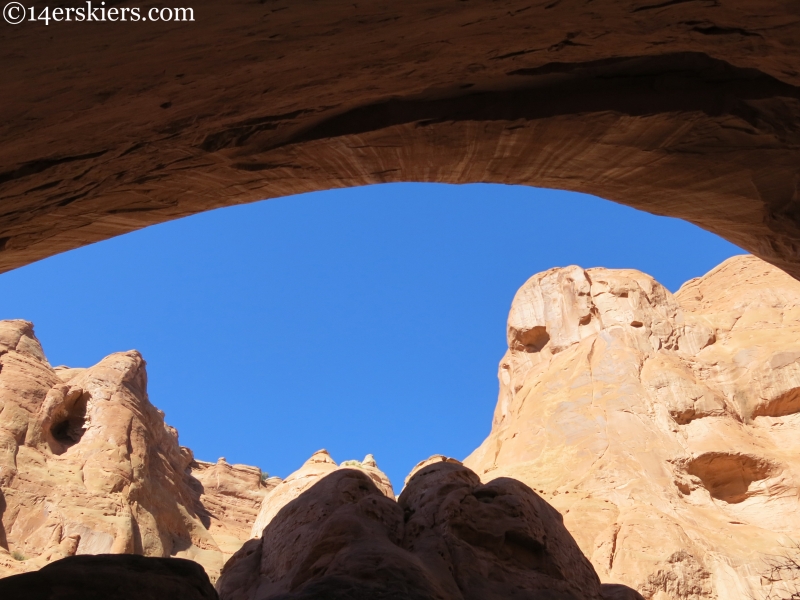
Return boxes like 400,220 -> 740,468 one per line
465,256 -> 800,600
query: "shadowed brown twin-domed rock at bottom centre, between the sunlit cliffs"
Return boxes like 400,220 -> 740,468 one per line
217,462 -> 641,600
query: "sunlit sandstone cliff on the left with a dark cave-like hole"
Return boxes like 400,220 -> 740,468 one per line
0,321 -> 276,579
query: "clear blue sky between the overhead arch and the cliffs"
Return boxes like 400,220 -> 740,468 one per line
0,183 -> 743,490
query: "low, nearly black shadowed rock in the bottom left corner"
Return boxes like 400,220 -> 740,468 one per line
0,554 -> 218,600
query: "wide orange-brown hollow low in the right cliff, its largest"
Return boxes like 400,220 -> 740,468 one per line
686,452 -> 776,504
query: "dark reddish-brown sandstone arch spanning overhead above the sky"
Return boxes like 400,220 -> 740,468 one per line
0,0 -> 800,277
